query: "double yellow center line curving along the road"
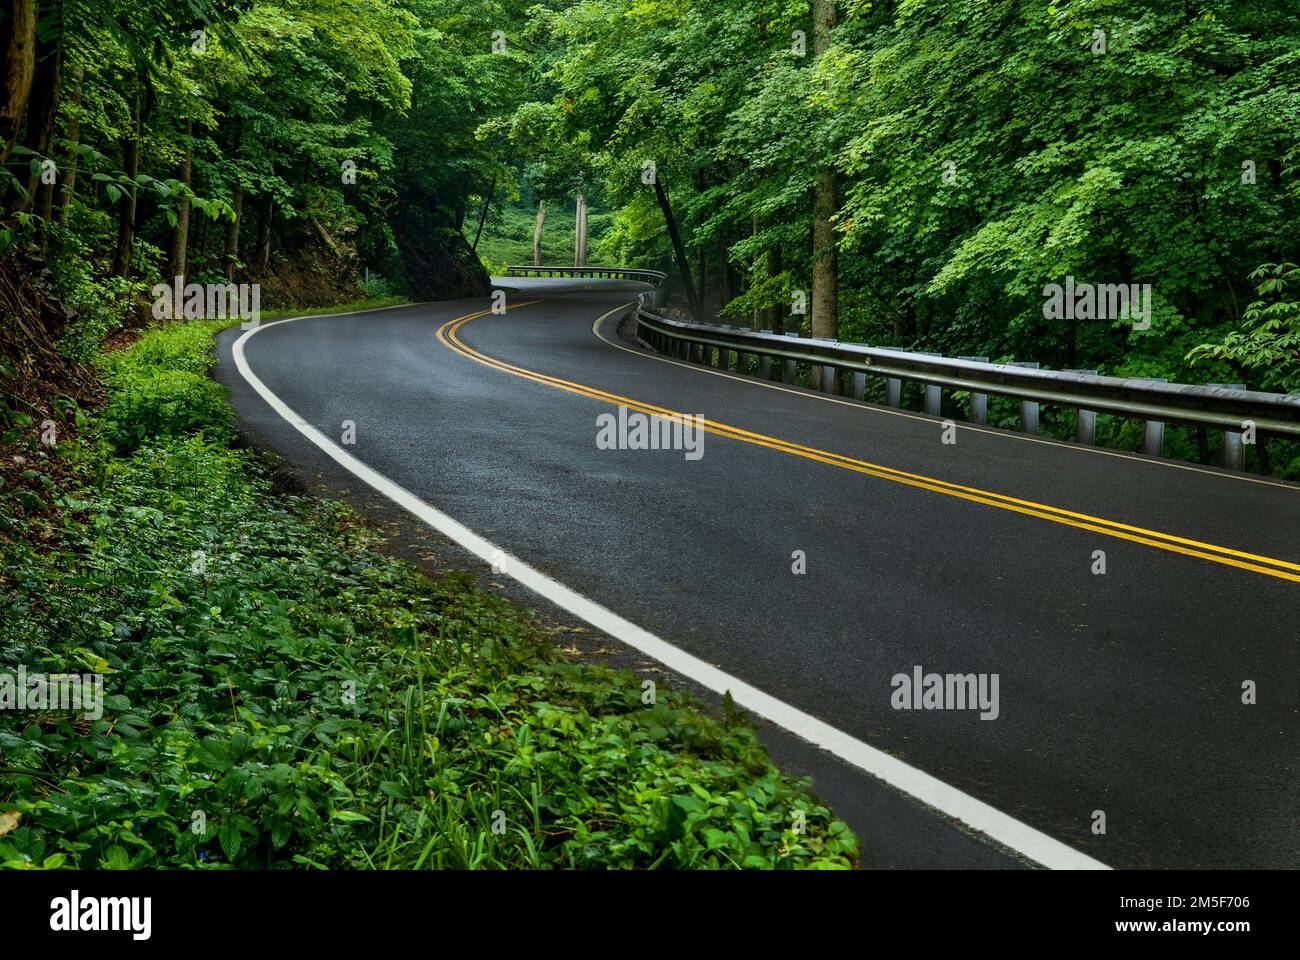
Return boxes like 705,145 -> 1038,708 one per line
437,300 -> 1300,583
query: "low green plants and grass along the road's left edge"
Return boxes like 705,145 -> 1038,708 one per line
0,306 -> 857,869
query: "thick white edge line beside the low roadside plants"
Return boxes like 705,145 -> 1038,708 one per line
230,304 -> 1110,870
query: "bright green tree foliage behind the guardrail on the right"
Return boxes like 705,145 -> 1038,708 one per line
514,0 -> 1300,389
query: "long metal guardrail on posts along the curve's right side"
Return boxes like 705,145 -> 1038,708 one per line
499,267 -> 1300,470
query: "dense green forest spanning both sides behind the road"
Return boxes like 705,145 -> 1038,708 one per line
0,0 -> 1300,390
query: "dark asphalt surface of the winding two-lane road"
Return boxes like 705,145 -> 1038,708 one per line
218,281 -> 1300,869
